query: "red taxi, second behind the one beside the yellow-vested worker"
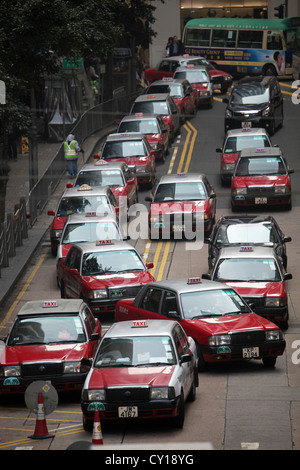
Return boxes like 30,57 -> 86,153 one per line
118,113 -> 170,162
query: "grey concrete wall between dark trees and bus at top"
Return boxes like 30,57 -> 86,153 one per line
149,0 -> 181,67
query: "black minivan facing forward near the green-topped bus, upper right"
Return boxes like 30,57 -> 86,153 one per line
223,76 -> 283,135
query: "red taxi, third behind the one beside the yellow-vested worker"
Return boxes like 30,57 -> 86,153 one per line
129,93 -> 181,142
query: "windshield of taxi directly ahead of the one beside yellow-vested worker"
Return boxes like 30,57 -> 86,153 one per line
56,195 -> 111,217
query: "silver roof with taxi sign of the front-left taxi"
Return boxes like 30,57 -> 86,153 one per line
18,299 -> 84,316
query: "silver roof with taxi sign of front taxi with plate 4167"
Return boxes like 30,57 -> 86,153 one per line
105,320 -> 180,338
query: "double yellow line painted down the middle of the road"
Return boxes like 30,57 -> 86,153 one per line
143,121 -> 197,281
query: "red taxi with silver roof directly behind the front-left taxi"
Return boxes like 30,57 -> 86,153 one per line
57,240 -> 154,315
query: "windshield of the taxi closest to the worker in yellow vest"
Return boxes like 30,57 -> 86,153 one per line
75,170 -> 124,187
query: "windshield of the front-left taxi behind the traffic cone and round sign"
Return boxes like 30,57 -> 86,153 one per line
7,314 -> 87,346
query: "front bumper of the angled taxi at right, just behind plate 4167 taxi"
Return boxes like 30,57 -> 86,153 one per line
202,340 -> 286,363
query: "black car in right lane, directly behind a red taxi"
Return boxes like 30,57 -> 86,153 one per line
204,215 -> 292,269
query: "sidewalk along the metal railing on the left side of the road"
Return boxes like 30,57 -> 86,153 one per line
0,126 -> 116,305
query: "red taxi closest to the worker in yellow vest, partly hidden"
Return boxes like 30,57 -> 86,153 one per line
74,159 -> 138,207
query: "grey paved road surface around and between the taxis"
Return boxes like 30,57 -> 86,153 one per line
0,84 -> 300,450
